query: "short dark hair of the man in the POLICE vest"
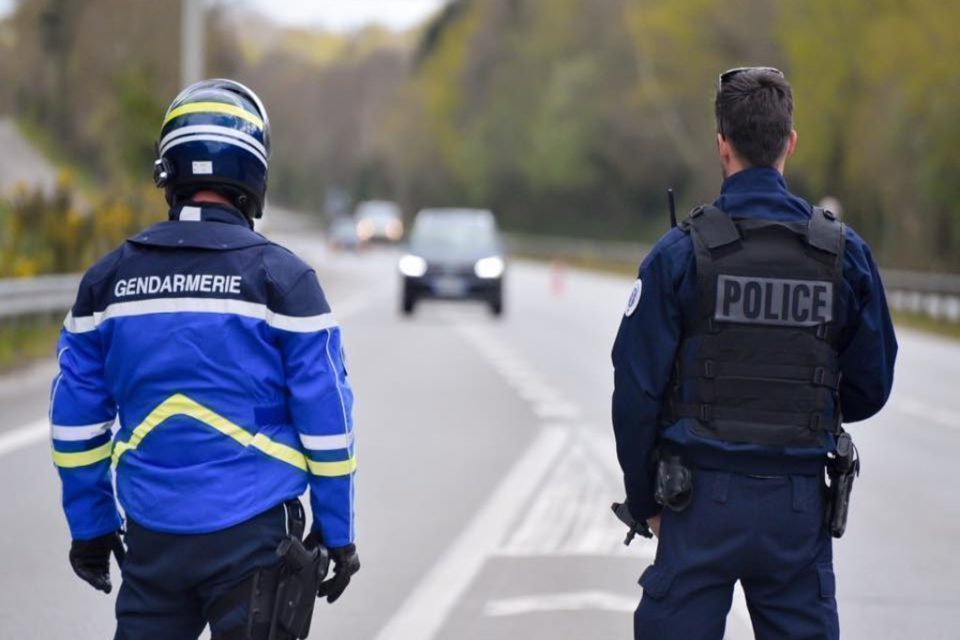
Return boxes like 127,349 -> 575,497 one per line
714,69 -> 793,167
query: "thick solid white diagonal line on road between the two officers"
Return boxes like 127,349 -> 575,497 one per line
376,427 -> 569,640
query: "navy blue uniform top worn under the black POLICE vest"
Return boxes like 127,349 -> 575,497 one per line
613,168 -> 897,519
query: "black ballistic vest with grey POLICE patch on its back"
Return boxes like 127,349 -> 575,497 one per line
665,206 -> 844,447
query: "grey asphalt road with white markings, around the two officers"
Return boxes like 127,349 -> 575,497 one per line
0,208 -> 960,640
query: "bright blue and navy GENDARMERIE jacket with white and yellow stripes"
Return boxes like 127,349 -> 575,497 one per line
50,204 -> 356,547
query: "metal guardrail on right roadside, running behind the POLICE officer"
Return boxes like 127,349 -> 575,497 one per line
506,234 -> 960,323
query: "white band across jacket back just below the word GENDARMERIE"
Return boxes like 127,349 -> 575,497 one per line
64,298 -> 337,333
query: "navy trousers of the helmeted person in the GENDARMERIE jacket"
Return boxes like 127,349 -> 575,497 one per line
114,504 -> 287,640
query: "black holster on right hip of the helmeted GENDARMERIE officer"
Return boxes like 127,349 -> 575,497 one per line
207,500 -> 330,640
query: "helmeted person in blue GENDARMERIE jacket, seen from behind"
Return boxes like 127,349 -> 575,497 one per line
50,80 -> 359,640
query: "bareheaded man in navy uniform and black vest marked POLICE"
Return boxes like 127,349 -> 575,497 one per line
613,68 -> 897,640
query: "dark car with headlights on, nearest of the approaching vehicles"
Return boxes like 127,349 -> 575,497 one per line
399,209 -> 506,316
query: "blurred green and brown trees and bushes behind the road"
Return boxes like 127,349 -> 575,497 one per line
0,0 -> 960,273
